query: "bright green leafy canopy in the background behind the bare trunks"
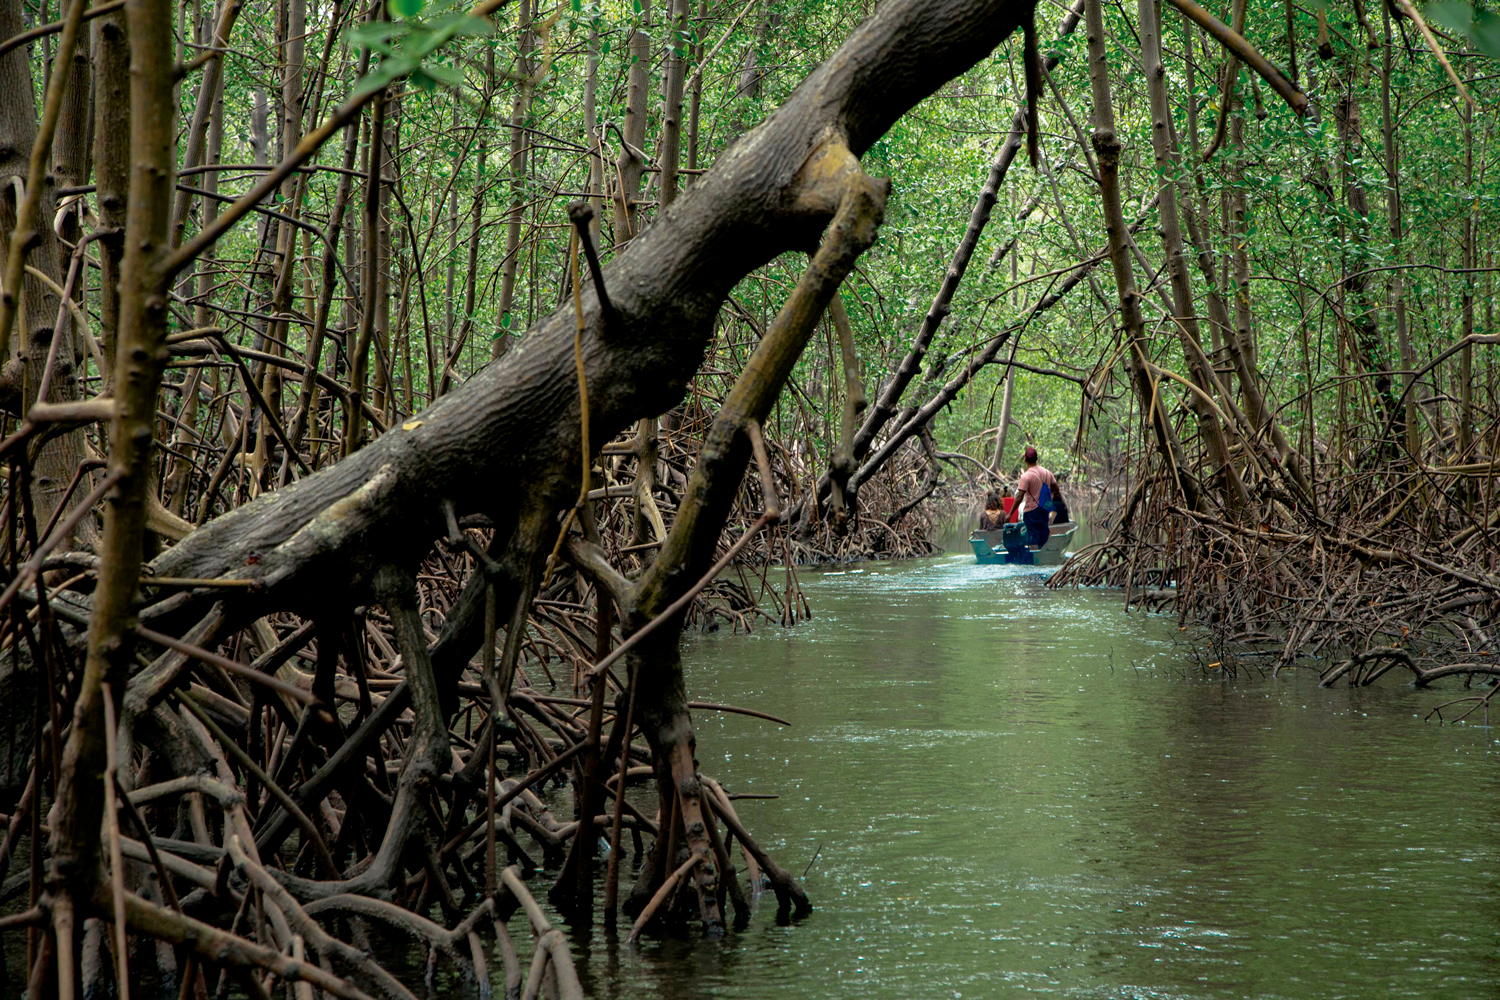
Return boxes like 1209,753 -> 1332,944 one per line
76,0 -> 1500,497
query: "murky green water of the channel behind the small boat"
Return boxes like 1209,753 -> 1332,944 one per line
575,555 -> 1500,1000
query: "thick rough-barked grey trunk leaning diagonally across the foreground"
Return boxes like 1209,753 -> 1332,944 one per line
155,0 -> 1028,626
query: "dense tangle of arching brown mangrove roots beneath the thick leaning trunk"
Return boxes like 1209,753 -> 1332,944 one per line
0,532 -> 810,1000
